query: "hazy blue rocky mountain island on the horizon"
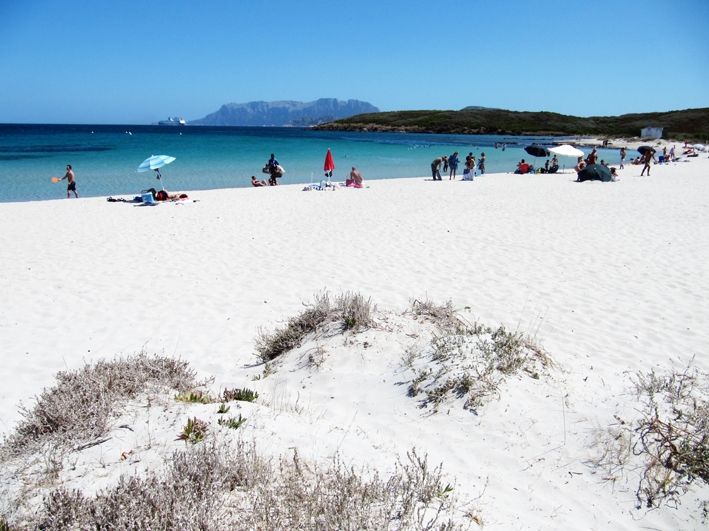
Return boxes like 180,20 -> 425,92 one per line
189,98 -> 379,126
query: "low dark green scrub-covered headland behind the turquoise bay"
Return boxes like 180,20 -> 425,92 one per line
316,107 -> 709,140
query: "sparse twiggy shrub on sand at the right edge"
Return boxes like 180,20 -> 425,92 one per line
591,360 -> 709,520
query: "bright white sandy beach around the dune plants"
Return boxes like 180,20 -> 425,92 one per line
0,154 -> 709,530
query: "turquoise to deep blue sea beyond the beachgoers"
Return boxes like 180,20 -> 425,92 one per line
0,124 -> 618,202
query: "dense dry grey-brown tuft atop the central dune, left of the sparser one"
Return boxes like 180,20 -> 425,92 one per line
256,292 -> 375,363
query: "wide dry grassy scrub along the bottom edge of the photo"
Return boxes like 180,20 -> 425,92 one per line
32,441 -> 469,531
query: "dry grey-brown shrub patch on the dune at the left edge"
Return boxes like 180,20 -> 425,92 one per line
4,354 -> 197,452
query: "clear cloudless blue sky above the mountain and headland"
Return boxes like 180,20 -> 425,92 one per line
0,0 -> 709,124
